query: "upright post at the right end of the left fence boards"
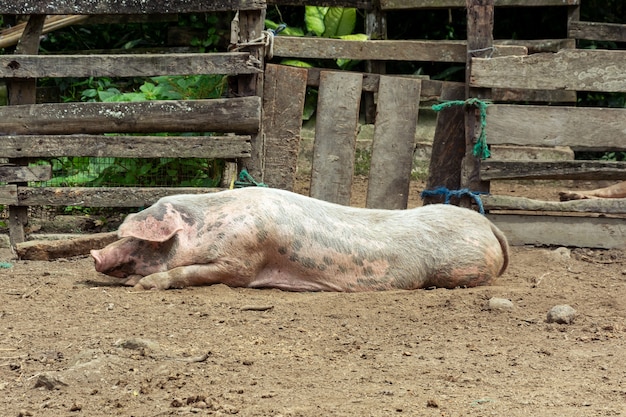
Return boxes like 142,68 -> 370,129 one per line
231,9 -> 265,182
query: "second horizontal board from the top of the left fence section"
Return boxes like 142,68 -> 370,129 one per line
0,52 -> 262,78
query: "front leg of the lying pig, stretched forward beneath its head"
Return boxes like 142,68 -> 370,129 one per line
135,263 -> 251,290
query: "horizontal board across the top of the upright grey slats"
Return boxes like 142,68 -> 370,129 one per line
274,36 -> 527,62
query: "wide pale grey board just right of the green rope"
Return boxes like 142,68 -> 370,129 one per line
486,104 -> 626,151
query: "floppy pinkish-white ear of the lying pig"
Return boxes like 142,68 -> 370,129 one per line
117,206 -> 183,242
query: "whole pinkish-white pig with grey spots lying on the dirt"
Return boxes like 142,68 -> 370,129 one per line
91,187 -> 509,292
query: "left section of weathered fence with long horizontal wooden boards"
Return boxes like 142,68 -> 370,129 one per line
0,0 -> 266,244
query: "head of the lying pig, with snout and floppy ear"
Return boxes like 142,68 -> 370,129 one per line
91,200 -> 188,278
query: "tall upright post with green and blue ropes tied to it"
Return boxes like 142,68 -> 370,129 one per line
460,0 -> 494,207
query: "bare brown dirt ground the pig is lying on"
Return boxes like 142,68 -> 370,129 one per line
0,177 -> 626,417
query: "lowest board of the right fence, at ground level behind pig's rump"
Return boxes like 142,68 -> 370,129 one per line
487,214 -> 626,249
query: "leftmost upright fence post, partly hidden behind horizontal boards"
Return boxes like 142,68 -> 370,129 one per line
7,15 -> 46,247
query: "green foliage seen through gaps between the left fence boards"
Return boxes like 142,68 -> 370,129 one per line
37,75 -> 226,187
